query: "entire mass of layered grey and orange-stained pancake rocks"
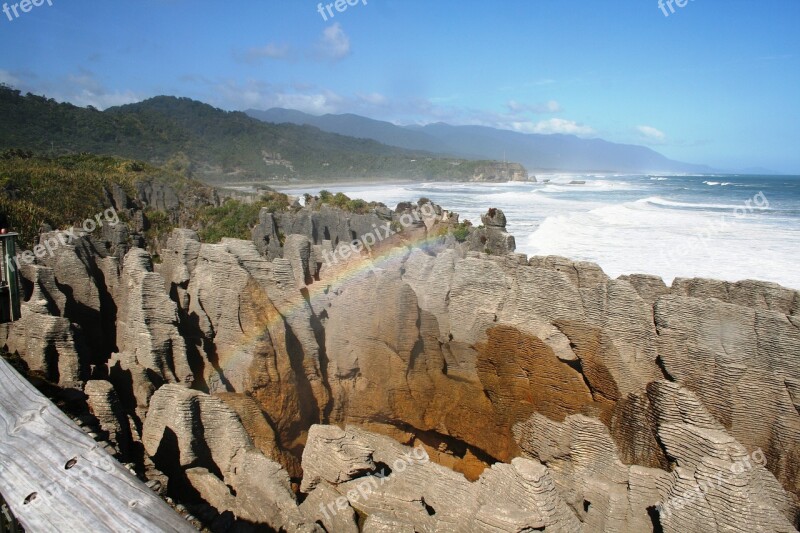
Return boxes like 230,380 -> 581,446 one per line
6,204 -> 800,531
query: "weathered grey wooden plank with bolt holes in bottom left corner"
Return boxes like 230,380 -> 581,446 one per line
0,357 -> 196,533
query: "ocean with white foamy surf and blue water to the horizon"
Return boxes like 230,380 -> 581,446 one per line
284,174 -> 800,289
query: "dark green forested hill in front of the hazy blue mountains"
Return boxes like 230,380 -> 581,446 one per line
0,86 -> 520,183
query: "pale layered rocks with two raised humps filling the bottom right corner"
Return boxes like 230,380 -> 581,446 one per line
514,381 -> 797,532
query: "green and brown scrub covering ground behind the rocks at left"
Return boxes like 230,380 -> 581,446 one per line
0,149 -> 392,255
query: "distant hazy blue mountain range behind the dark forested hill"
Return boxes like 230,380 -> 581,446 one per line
245,108 -> 714,173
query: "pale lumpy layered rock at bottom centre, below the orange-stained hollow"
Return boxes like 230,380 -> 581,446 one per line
303,426 -> 581,532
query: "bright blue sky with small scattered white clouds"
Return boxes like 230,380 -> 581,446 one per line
0,0 -> 800,174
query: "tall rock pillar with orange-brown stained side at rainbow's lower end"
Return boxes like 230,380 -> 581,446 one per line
187,239 -> 327,449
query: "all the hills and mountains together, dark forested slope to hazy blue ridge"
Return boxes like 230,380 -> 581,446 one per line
0,87 -> 713,182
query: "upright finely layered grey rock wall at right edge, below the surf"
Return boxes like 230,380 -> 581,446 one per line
654,296 -> 800,493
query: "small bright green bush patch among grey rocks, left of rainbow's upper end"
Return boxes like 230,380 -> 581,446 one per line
198,193 -> 289,243
